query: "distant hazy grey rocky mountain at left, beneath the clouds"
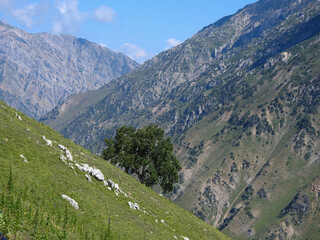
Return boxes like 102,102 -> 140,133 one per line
0,21 -> 138,118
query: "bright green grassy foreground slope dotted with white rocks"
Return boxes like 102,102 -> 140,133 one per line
0,102 -> 228,239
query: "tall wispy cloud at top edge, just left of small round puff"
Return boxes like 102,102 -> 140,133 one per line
52,0 -> 88,34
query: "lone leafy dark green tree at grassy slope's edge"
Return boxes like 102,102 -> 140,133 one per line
103,124 -> 181,192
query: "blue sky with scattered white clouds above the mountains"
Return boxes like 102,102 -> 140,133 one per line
0,0 -> 256,63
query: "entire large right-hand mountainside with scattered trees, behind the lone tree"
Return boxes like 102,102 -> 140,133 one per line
45,0 -> 320,239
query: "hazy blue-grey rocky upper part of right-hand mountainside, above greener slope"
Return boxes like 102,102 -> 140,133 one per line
44,0 -> 320,151
